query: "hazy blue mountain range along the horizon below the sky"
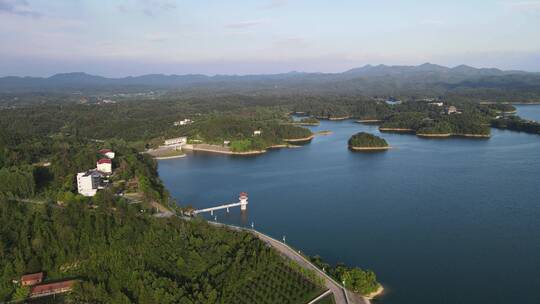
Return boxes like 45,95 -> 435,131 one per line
0,63 -> 540,94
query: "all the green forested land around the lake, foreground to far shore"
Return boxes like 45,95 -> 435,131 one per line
0,89 -> 540,303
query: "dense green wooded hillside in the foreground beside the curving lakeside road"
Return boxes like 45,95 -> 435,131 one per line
0,200 -> 322,304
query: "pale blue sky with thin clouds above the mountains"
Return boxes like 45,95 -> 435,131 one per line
0,0 -> 540,77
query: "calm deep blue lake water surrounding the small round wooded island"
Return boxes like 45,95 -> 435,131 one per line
159,106 -> 540,304
